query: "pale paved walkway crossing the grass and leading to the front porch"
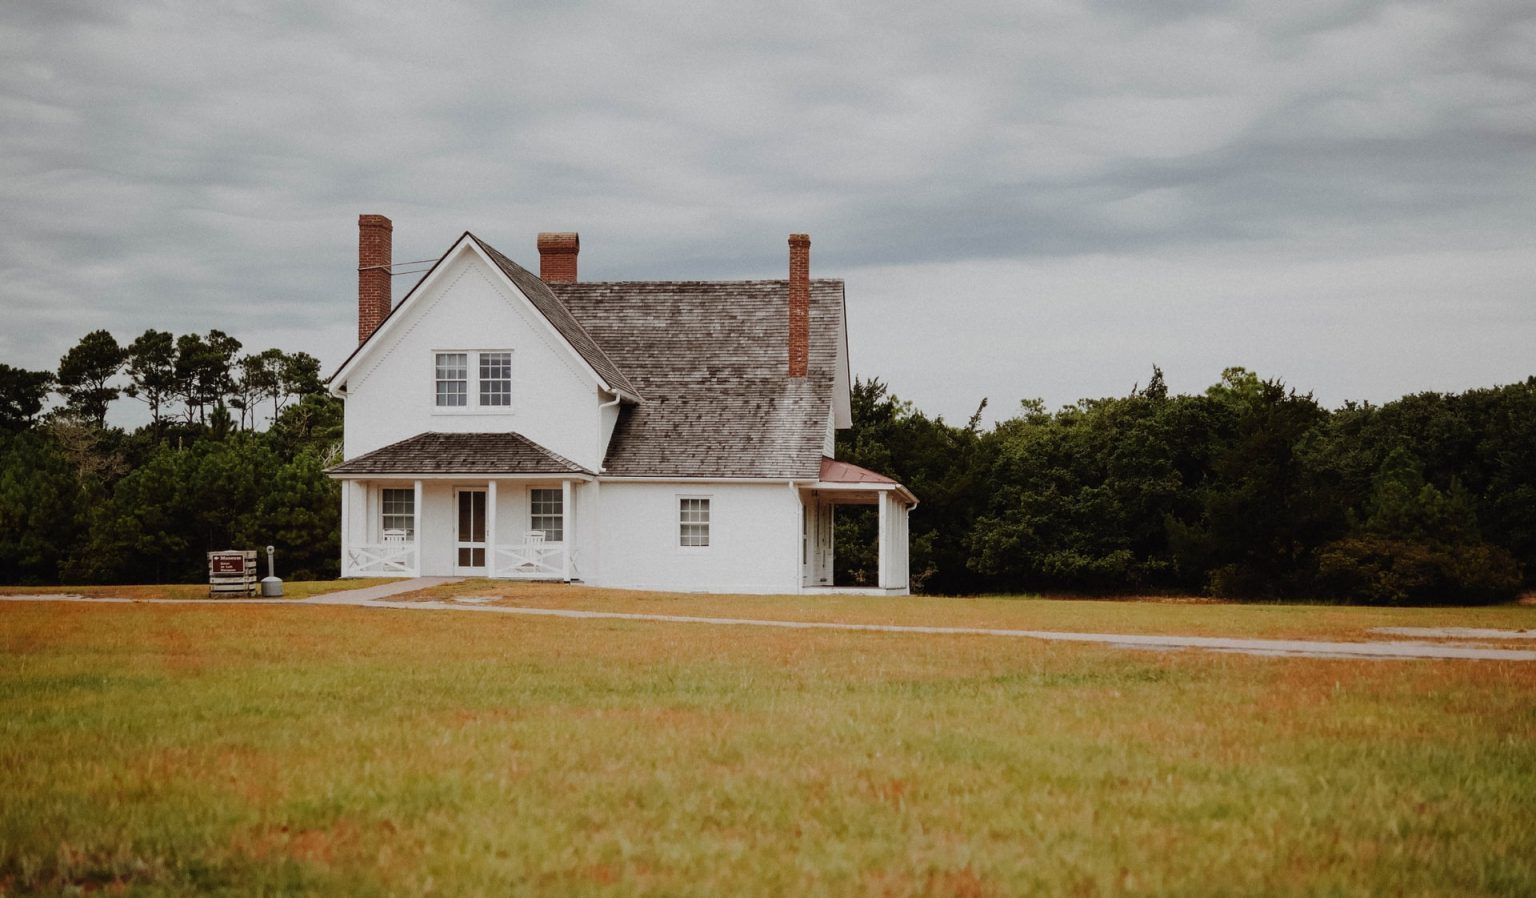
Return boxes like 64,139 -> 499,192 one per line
0,577 -> 1536,662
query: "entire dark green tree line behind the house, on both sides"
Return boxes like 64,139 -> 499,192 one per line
0,330 -> 1536,603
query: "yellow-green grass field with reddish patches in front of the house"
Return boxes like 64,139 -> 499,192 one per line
0,583 -> 1536,896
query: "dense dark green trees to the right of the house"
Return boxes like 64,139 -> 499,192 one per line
837,368 -> 1536,603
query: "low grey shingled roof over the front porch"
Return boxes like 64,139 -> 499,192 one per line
327,433 -> 591,474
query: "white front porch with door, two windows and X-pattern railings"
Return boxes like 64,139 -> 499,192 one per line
341,477 -> 584,582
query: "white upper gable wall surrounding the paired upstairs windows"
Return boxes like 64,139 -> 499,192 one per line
344,250 -> 605,470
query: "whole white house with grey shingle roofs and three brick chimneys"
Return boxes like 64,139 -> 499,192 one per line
330,215 -> 917,594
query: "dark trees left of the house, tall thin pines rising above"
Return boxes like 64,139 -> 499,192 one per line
0,330 -> 341,583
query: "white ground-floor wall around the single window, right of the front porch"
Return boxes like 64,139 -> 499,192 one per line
585,480 -> 802,594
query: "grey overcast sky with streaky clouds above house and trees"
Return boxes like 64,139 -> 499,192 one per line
0,0 -> 1536,419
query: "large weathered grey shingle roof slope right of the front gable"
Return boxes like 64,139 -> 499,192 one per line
548,279 -> 843,480
